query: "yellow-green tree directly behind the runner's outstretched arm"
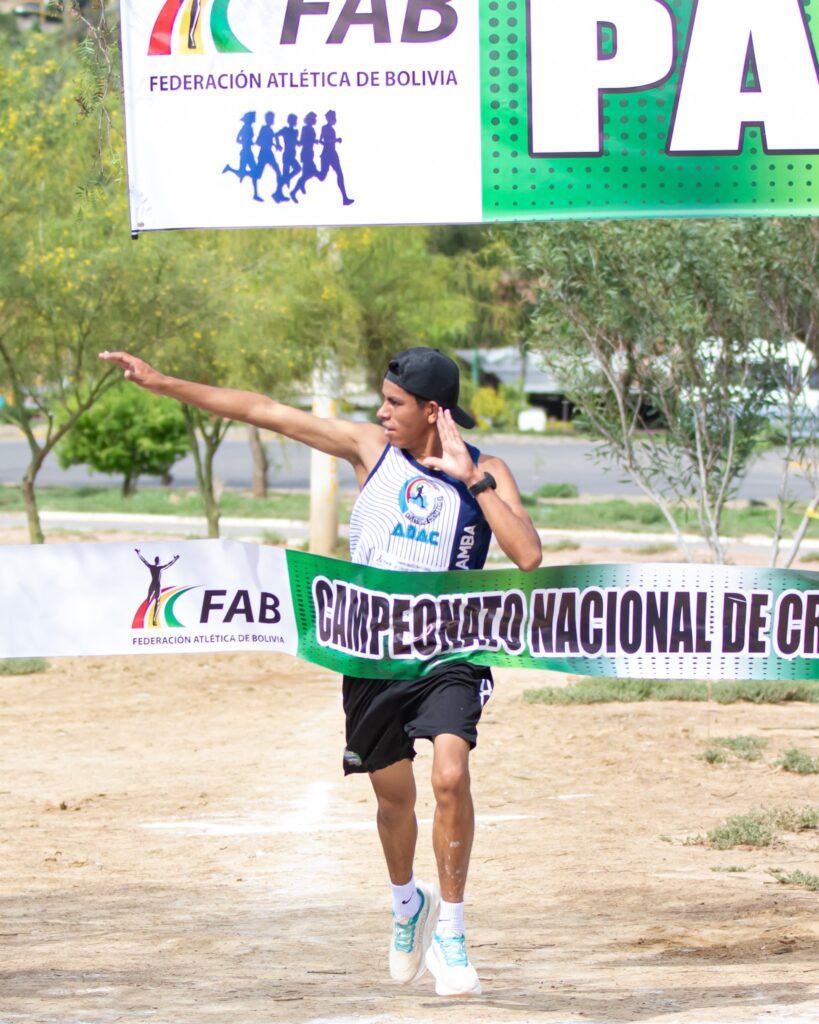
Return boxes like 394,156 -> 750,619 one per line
146,230 -> 357,537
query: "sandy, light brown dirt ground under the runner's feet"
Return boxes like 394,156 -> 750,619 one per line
0,531 -> 819,1024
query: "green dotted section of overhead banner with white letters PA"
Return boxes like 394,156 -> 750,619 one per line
481,0 -> 819,220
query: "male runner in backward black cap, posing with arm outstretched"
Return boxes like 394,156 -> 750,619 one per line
100,347 -> 542,995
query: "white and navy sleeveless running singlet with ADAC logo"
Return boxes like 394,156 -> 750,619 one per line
350,444 -> 491,571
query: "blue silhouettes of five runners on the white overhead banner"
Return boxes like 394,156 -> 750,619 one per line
222,111 -> 355,206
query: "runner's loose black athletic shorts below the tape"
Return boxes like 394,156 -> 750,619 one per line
342,662 -> 493,775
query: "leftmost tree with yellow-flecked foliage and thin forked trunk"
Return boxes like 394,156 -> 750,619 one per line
0,35 -> 123,542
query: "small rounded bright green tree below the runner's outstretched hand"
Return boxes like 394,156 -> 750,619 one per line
57,386 -> 188,497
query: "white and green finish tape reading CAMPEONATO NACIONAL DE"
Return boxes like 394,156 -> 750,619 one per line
0,541 -> 819,679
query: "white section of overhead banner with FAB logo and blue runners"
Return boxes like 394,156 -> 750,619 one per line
121,0 -> 481,230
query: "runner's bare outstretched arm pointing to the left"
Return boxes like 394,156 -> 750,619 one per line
99,352 -> 384,470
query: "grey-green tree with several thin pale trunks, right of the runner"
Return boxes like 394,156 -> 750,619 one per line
512,221 -> 776,562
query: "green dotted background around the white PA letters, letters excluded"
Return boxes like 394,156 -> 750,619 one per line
480,0 -> 819,221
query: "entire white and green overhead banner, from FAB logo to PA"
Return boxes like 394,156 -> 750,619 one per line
122,0 -> 819,231
